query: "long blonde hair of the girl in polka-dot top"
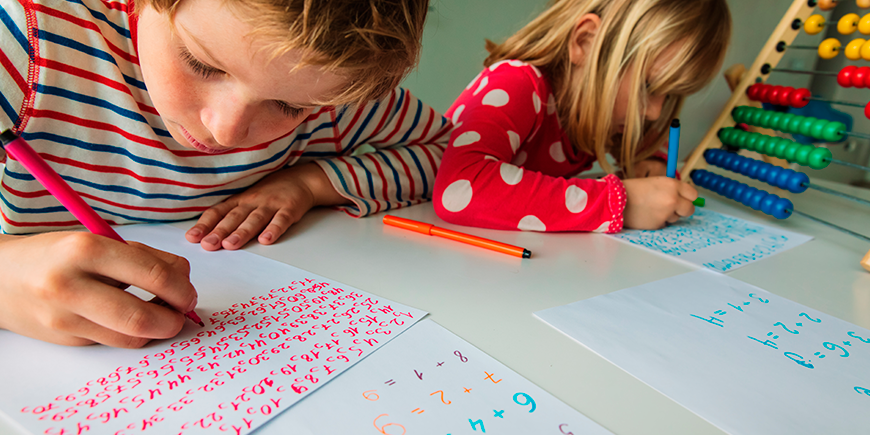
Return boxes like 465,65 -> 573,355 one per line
484,0 -> 731,177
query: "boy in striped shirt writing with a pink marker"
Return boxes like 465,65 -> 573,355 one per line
0,0 -> 450,347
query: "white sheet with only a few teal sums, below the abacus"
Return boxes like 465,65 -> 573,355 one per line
535,269 -> 870,435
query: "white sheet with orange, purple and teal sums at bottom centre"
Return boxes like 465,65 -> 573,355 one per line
257,320 -> 611,435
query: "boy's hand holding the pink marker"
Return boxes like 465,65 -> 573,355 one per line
0,232 -> 197,348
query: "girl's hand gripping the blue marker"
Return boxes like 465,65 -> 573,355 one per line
622,177 -> 698,230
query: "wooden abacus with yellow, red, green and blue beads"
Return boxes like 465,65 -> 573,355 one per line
682,0 -> 870,271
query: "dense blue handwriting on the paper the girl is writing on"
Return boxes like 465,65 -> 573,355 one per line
614,209 -> 789,272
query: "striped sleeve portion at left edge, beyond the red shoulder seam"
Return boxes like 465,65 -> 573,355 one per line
0,0 -> 30,134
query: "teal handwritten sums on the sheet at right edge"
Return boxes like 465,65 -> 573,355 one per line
690,293 -> 870,396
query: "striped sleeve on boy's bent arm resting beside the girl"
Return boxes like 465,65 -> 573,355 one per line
315,88 -> 452,217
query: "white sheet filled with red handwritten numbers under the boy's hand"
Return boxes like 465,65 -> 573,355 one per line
0,226 -> 425,435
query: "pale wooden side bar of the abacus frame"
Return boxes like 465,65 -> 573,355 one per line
681,0 -> 870,271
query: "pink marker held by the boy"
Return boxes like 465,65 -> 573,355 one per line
0,130 -> 205,326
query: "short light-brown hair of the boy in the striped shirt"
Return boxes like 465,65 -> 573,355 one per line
135,0 -> 429,105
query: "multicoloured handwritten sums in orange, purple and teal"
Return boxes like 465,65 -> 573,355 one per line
362,350 -> 573,435
